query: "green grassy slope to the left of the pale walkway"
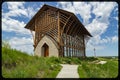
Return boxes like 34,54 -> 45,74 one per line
2,47 -> 62,78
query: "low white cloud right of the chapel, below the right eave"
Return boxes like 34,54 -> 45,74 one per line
87,35 -> 118,50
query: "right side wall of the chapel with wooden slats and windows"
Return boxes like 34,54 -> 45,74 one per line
60,11 -> 85,57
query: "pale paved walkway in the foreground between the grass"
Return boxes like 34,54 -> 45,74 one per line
56,64 -> 79,78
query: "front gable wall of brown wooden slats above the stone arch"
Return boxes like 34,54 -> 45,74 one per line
35,10 -> 58,47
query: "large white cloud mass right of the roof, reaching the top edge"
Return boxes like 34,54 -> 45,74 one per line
58,2 -> 118,50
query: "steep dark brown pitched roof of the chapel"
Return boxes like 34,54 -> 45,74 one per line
25,4 -> 92,37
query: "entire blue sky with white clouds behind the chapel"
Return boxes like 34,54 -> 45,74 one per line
2,1 -> 118,56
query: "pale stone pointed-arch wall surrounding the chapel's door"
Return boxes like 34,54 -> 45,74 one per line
35,35 -> 59,57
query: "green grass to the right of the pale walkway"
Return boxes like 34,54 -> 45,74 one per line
78,57 -> 118,78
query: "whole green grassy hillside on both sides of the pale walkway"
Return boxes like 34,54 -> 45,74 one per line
2,43 -> 118,78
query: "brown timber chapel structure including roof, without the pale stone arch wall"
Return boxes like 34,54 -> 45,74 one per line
25,4 -> 92,57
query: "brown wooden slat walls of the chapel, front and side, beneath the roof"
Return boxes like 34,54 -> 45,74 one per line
34,9 -> 85,57
